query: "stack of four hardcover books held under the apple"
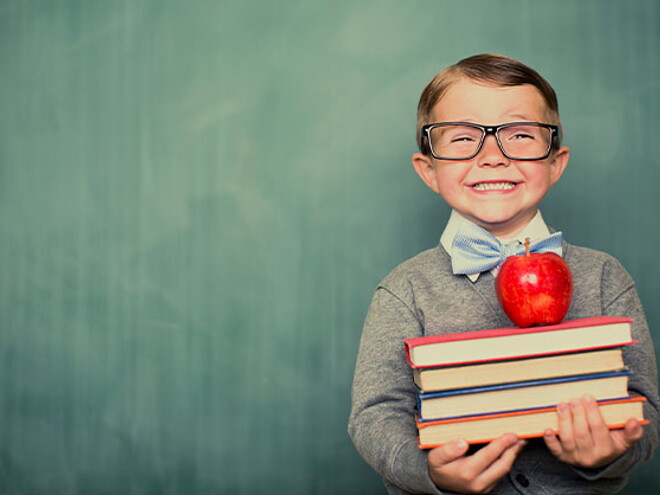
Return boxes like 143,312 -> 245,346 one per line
405,316 -> 645,448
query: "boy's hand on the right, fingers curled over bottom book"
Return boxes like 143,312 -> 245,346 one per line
543,395 -> 644,468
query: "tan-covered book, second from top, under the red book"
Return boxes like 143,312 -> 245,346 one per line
413,348 -> 624,392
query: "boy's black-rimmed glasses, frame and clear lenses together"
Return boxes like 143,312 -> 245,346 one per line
421,122 -> 559,160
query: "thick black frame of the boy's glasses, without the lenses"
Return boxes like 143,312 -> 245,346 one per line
420,122 -> 560,162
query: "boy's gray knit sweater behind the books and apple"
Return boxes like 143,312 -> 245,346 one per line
349,238 -> 660,495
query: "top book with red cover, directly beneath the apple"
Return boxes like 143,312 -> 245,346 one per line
404,316 -> 634,368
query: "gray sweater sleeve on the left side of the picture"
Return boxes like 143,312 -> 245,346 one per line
348,286 -> 441,494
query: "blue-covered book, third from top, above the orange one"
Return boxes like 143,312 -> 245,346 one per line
417,371 -> 631,420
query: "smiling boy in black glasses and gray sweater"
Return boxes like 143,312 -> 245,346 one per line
349,54 -> 659,494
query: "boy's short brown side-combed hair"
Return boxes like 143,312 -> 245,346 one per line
417,53 -> 561,155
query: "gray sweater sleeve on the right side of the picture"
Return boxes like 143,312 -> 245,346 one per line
576,259 -> 660,479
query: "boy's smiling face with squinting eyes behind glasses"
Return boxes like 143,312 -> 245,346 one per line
412,78 -> 569,237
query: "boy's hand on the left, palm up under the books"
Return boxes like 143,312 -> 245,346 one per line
427,433 -> 526,493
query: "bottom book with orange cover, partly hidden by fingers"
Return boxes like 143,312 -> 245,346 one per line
417,397 -> 648,449
